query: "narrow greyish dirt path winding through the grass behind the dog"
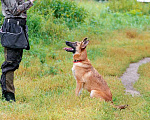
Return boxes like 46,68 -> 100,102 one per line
120,58 -> 150,96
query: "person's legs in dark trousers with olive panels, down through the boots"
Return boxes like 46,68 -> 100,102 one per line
1,48 -> 23,101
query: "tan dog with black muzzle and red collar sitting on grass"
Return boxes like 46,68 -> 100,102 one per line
64,38 -> 126,109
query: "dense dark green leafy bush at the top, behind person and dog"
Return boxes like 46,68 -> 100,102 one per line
33,0 -> 87,28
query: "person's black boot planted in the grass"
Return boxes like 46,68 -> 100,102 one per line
2,92 -> 16,102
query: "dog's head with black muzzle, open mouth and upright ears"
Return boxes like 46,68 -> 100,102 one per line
64,38 -> 89,54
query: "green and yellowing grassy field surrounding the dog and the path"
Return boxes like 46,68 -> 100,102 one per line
0,0 -> 150,120
